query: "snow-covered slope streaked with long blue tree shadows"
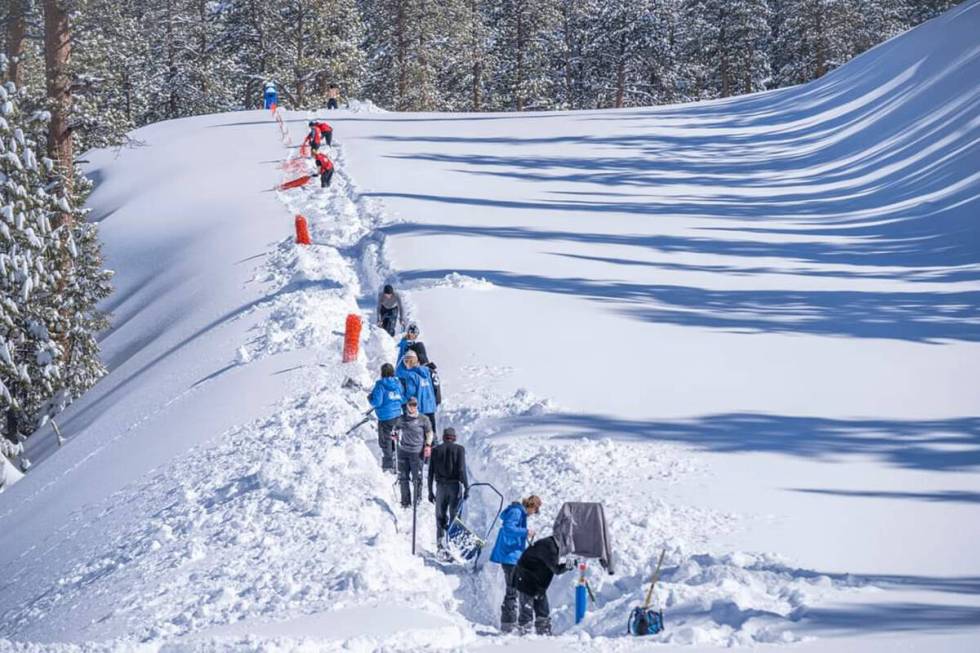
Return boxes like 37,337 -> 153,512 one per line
0,2 -> 980,651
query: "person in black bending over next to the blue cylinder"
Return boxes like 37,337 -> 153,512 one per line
514,535 -> 572,635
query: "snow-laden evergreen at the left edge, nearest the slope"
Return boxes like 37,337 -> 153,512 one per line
0,57 -> 110,438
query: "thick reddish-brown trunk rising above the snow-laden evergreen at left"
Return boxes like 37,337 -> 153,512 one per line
43,0 -> 74,196
